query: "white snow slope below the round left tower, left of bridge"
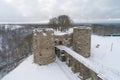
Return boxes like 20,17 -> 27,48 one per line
2,56 -> 78,80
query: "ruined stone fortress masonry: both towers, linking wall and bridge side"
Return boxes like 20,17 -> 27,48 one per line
33,27 -> 101,80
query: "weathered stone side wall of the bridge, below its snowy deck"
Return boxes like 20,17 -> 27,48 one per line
55,48 -> 102,80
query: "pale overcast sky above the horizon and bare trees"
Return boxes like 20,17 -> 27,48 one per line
0,0 -> 120,22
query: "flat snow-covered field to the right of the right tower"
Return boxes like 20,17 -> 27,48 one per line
90,35 -> 120,75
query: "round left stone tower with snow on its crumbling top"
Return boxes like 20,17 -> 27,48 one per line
33,29 -> 55,65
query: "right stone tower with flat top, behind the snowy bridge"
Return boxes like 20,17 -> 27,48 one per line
73,27 -> 91,58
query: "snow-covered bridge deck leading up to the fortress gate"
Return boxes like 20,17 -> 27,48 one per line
55,45 -> 120,80
